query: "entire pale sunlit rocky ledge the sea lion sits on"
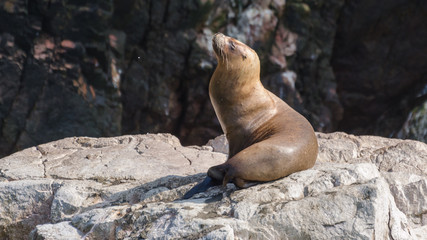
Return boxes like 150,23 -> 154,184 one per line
0,133 -> 427,239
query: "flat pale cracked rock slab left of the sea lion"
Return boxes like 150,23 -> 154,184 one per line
0,135 -> 226,183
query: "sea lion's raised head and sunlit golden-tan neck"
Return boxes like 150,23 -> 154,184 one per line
209,33 -> 271,134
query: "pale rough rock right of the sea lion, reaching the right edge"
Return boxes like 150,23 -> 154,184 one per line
317,133 -> 427,230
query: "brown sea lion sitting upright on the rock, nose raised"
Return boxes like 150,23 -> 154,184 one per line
183,33 -> 318,199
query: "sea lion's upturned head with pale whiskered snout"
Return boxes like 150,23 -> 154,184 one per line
212,33 -> 259,70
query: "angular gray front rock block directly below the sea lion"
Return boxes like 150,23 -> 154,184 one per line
113,163 -> 410,239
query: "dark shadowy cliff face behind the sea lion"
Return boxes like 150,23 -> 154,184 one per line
0,0 -> 427,155
